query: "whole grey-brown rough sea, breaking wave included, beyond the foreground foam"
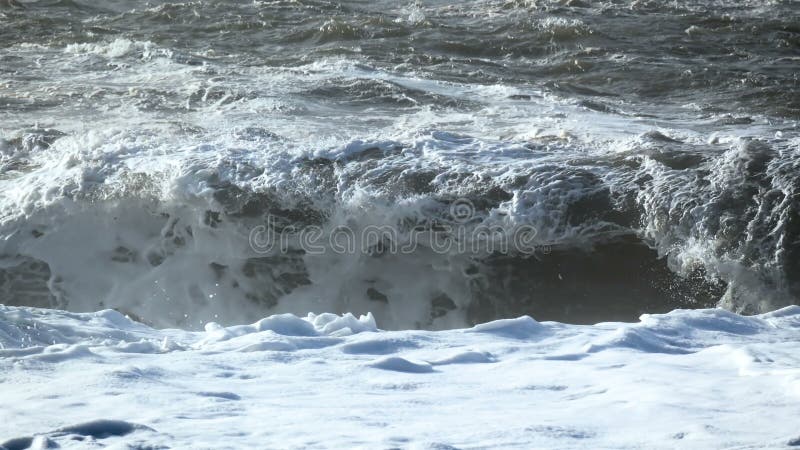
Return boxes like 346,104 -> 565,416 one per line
0,0 -> 800,329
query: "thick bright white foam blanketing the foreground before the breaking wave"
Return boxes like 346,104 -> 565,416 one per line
0,306 -> 800,449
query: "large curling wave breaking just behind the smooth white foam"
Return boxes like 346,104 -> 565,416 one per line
0,120 -> 800,328
